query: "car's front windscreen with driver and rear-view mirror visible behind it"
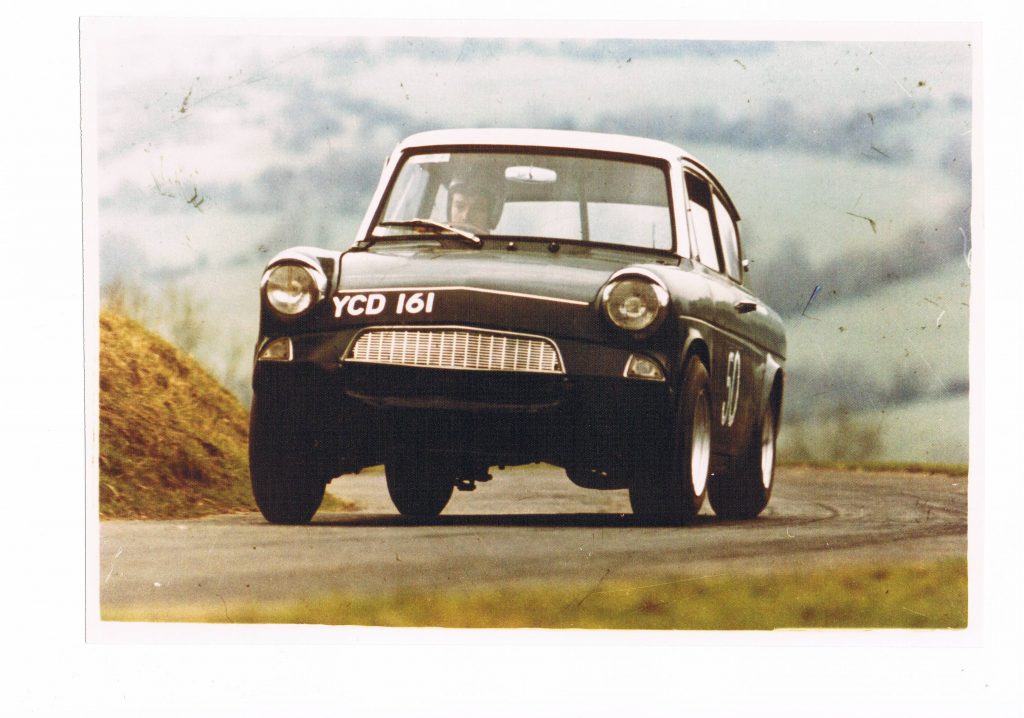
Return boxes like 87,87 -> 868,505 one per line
374,152 -> 674,250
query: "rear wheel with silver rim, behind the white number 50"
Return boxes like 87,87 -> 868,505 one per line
708,402 -> 778,518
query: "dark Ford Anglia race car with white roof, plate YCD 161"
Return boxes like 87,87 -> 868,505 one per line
250,129 -> 785,523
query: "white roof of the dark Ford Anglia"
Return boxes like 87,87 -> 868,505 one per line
398,128 -> 696,162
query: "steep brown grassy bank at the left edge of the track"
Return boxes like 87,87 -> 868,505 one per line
99,311 -> 255,518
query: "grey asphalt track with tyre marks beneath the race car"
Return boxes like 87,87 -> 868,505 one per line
96,465 -> 968,611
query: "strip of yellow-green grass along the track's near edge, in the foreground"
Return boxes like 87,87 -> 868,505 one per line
102,559 -> 968,630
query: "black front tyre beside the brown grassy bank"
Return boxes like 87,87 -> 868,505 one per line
249,397 -> 327,523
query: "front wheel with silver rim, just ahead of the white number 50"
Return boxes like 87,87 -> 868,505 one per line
630,356 -> 712,525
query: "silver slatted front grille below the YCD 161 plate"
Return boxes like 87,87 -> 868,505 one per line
345,327 -> 565,374
